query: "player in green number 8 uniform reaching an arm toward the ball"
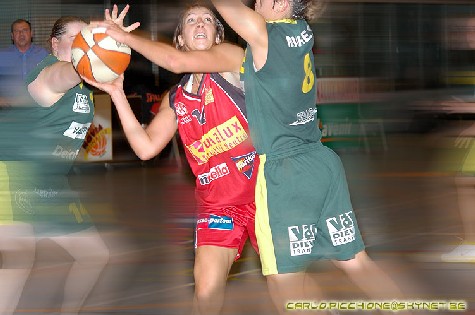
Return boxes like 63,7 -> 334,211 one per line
92,0 -> 412,313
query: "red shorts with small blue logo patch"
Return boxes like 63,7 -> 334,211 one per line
195,202 -> 259,260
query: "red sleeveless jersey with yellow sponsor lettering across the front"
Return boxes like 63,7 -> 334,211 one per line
170,73 -> 259,208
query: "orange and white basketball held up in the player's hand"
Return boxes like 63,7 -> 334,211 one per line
71,27 -> 130,83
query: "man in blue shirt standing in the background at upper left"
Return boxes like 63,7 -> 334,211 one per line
0,19 -> 49,105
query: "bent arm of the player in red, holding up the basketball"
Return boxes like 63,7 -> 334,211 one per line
83,75 -> 177,160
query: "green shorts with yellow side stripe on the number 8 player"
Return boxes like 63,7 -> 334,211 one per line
256,143 -> 364,275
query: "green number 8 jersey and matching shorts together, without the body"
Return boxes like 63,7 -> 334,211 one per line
241,19 -> 364,275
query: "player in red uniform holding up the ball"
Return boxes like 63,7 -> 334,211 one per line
85,5 -> 259,315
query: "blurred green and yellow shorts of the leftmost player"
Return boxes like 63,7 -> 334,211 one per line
0,161 -> 93,236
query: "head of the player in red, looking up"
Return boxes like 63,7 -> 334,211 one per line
179,7 -> 218,50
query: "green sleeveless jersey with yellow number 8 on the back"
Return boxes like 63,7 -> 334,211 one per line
241,20 -> 321,156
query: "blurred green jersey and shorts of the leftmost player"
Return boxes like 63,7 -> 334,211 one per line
0,55 -> 94,235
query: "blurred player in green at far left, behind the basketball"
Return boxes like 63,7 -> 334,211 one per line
0,10 -> 138,315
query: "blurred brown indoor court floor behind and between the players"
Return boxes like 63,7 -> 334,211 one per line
13,134 -> 475,315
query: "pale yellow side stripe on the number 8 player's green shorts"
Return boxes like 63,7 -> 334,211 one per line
255,154 -> 278,276
